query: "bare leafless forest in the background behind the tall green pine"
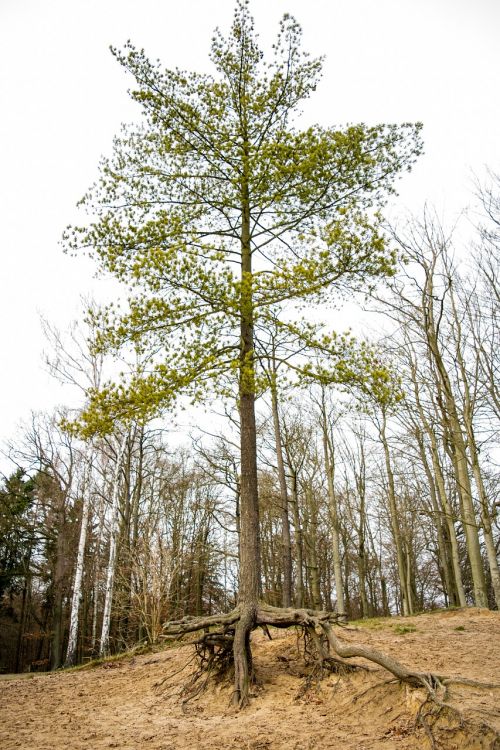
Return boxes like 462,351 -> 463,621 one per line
0,180 -> 500,672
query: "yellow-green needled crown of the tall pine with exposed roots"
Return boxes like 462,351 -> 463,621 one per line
65,2 -> 421,434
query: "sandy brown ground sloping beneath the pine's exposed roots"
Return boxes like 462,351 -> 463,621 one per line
0,609 -> 500,750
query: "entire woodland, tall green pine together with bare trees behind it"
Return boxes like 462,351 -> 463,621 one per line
0,3 -> 500,705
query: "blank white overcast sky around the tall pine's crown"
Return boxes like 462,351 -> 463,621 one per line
0,0 -> 500,462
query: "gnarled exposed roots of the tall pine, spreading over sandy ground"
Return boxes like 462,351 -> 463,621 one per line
164,604 -> 500,747
